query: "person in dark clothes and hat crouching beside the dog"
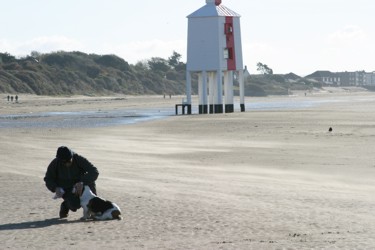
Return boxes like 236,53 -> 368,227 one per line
44,146 -> 99,218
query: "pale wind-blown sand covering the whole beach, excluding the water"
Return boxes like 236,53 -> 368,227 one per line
0,89 -> 375,249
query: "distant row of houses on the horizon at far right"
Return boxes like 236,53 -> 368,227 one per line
305,71 -> 375,86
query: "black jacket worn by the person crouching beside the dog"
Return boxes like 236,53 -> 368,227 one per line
44,153 -> 99,193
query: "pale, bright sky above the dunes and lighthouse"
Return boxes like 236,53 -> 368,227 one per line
0,0 -> 375,76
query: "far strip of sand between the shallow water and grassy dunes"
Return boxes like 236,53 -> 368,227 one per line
0,87 -> 373,115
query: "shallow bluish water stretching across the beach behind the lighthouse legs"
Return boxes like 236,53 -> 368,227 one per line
0,99 -> 334,128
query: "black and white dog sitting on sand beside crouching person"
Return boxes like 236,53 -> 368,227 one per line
80,185 -> 122,220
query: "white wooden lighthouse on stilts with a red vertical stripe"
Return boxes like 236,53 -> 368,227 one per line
186,0 -> 245,114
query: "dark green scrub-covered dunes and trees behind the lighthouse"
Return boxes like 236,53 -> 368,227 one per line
0,51 -> 316,96
